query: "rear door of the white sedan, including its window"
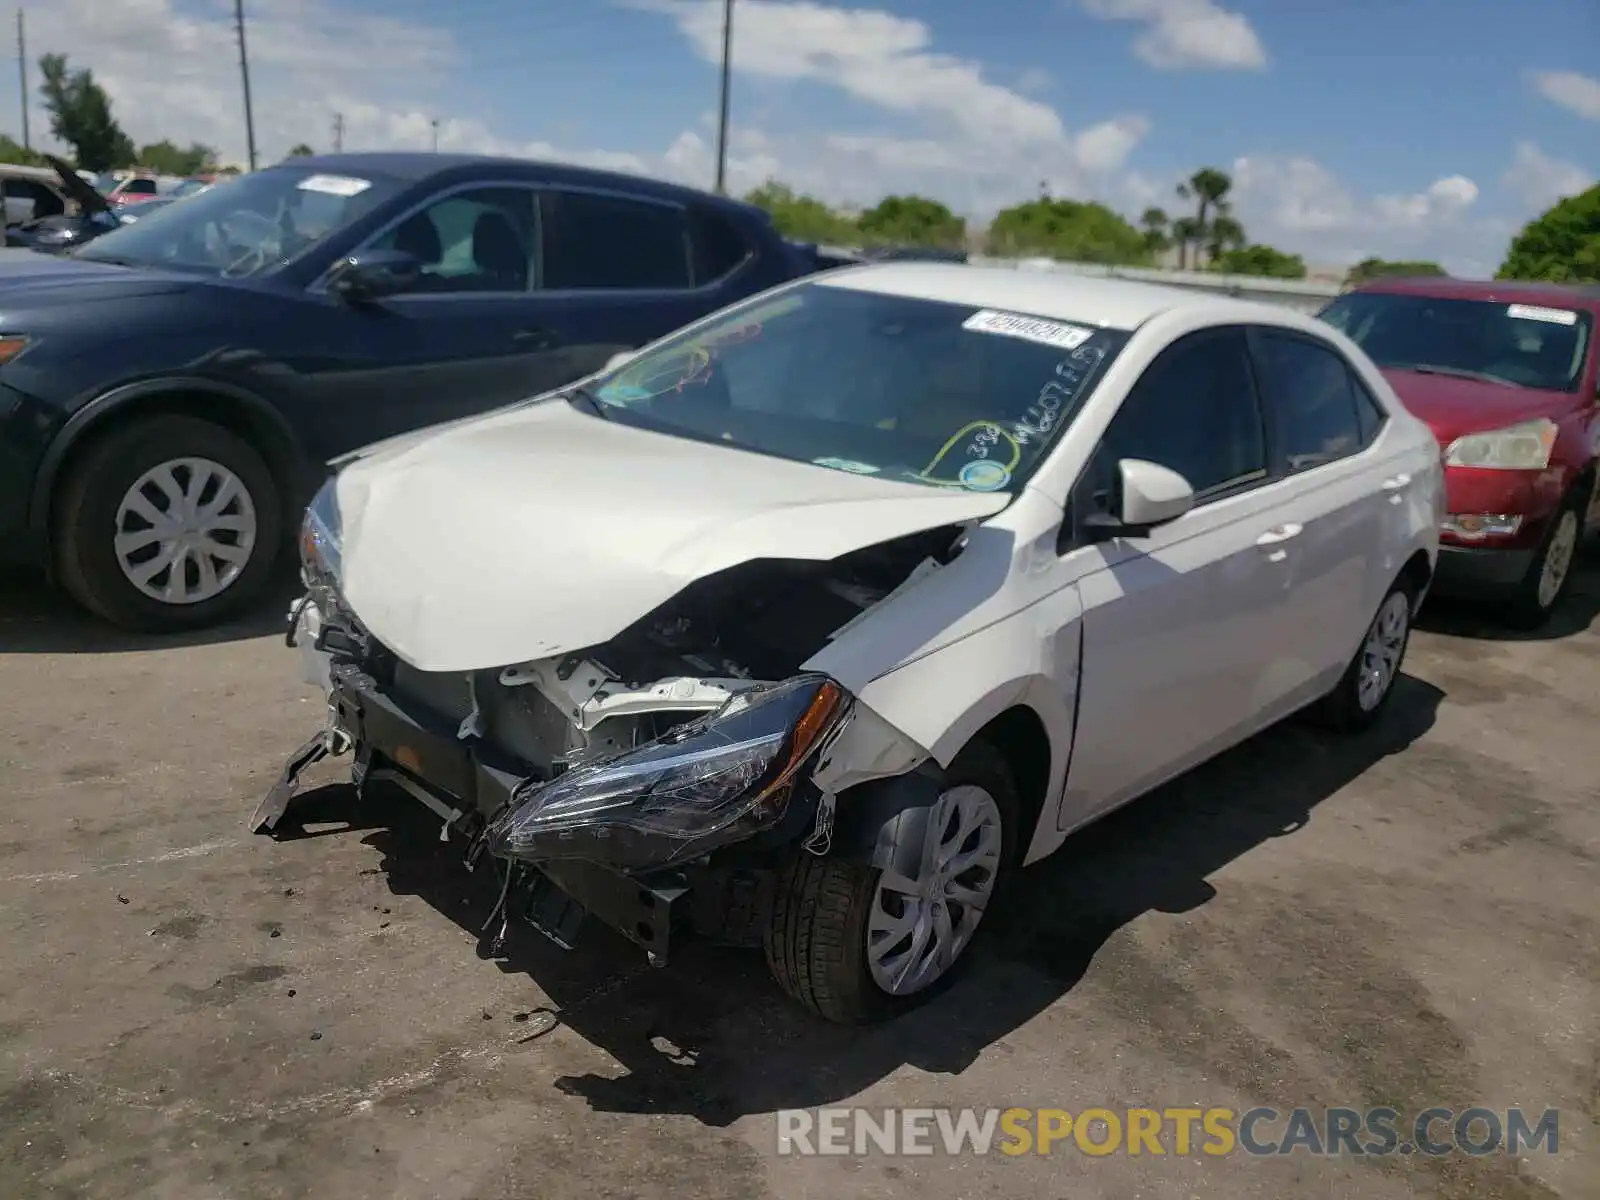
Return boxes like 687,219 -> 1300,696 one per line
1250,326 -> 1413,701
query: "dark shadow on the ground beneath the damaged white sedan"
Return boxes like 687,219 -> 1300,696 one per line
285,675 -> 1443,1126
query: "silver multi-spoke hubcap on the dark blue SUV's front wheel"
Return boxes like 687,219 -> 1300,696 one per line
114,458 -> 256,605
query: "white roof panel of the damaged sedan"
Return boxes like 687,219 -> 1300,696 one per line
813,262 -> 1306,330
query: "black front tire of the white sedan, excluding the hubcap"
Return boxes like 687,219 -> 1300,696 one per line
763,741 -> 1021,1024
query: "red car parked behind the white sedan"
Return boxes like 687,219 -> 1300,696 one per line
1322,278 -> 1600,629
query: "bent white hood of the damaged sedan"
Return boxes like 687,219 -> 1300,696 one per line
334,398 -> 1010,670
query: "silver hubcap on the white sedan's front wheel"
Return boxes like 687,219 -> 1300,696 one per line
867,784 -> 1002,995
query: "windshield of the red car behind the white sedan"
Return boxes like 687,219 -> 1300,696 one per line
1322,291 -> 1592,392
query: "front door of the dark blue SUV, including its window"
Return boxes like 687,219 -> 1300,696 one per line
300,182 -> 560,453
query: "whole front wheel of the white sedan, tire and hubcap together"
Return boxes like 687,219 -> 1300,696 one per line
765,742 -> 1018,1024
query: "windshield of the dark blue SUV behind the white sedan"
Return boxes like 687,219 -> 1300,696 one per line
77,166 -> 402,277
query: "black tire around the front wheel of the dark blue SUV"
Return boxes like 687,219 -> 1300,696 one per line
53,413 -> 283,634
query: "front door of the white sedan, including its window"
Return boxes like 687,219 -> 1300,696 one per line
1061,328 -> 1294,827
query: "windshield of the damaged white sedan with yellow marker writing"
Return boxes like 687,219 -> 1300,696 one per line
579,282 -> 1128,491
